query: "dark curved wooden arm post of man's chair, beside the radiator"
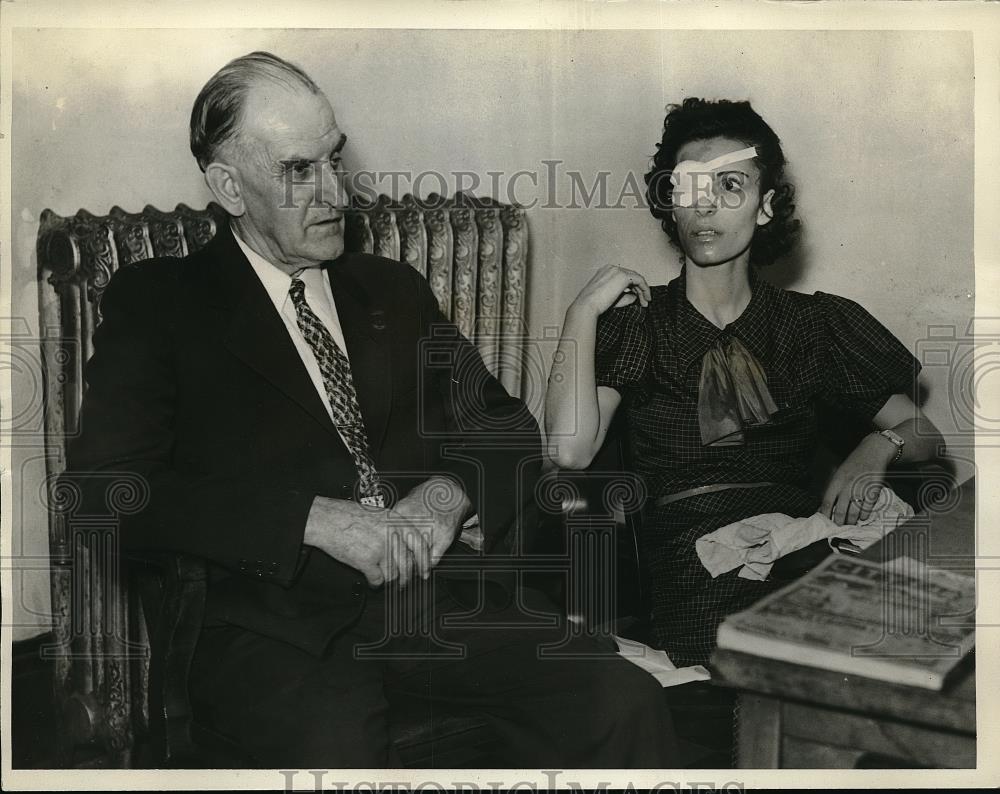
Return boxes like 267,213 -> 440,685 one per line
125,551 -> 208,766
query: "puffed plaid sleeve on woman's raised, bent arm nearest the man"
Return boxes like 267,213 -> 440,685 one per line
594,303 -> 653,396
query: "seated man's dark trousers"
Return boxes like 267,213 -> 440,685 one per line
192,576 -> 677,769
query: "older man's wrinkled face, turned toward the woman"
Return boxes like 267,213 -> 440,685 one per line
227,83 -> 347,269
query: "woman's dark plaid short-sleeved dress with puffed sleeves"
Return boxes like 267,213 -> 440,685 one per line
596,270 -> 920,665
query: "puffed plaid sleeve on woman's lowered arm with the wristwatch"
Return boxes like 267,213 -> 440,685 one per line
816,292 -> 920,419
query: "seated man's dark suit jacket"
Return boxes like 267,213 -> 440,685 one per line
68,224 -> 540,653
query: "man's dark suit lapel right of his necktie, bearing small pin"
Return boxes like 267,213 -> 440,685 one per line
327,260 -> 392,461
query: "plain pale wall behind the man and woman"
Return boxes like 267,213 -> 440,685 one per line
11,29 -> 974,639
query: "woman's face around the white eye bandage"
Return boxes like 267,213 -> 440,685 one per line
673,137 -> 774,267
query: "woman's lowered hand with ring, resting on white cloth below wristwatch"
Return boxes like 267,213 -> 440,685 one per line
819,435 -> 896,526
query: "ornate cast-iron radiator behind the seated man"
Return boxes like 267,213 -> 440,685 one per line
37,193 -> 528,766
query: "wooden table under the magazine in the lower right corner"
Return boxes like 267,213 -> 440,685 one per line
712,480 -> 976,769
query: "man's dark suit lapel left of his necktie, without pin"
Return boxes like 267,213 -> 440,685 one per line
205,229 -> 346,440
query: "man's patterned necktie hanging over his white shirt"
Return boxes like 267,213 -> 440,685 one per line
288,276 -> 385,507
